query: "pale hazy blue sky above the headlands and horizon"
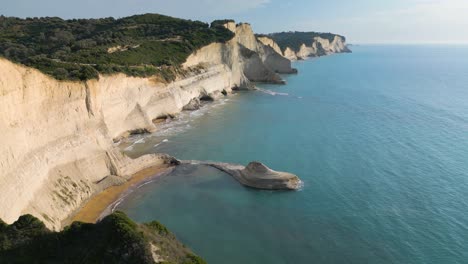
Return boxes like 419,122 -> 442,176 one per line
0,0 -> 468,43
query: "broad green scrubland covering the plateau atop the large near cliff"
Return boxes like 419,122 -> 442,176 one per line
0,14 -> 233,81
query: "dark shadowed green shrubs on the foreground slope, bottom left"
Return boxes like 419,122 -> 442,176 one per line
0,212 -> 206,264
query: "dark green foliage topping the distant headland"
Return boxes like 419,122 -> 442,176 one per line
259,31 -> 345,52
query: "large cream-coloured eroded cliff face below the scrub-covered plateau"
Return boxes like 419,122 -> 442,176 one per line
0,21 -> 293,230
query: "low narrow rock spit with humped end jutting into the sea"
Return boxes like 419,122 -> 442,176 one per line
182,161 -> 302,190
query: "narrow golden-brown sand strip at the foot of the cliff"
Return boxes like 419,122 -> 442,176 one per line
70,165 -> 173,223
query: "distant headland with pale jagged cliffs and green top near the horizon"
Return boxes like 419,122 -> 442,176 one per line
257,32 -> 351,60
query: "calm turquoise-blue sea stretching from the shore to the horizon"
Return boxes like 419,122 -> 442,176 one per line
118,45 -> 468,264
